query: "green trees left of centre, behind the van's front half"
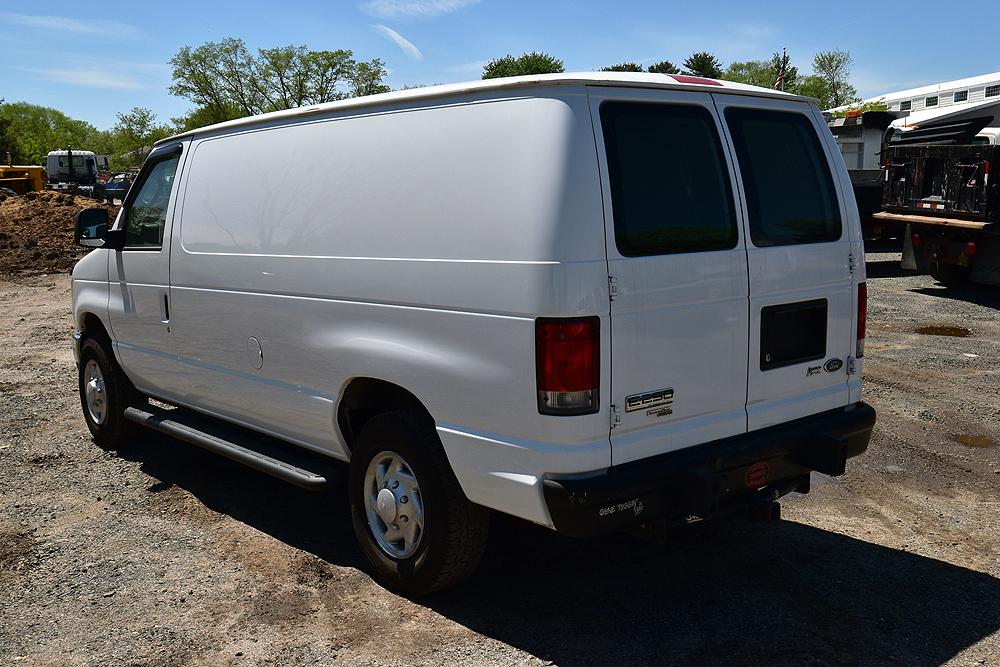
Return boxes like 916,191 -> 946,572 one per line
0,38 -> 391,171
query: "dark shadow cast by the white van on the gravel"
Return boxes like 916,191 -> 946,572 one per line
113,434 -> 1000,665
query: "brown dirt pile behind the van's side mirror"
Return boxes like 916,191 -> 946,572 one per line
0,192 -> 119,275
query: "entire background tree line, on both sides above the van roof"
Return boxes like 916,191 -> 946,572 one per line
0,38 -> 858,171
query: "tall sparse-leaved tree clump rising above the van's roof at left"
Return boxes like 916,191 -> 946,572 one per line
170,37 -> 388,122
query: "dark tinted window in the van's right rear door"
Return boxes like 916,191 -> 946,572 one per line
726,107 -> 842,247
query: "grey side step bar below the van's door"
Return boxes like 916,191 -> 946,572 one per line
125,405 -> 345,489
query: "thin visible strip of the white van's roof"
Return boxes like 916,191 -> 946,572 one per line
155,72 -> 816,146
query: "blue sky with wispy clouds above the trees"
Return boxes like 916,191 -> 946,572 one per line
0,0 -> 1000,128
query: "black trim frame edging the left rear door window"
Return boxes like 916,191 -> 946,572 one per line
598,98 -> 742,258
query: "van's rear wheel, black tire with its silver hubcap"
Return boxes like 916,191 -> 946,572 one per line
348,410 -> 488,595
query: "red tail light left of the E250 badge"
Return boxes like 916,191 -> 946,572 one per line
535,317 -> 601,415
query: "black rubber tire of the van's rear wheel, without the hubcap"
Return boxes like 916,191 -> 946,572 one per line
348,410 -> 489,595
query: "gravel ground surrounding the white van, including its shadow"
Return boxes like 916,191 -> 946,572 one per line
0,253 -> 1000,666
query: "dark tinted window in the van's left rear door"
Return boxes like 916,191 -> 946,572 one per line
601,102 -> 739,257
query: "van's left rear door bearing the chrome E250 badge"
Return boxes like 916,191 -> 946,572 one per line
588,86 -> 749,465
